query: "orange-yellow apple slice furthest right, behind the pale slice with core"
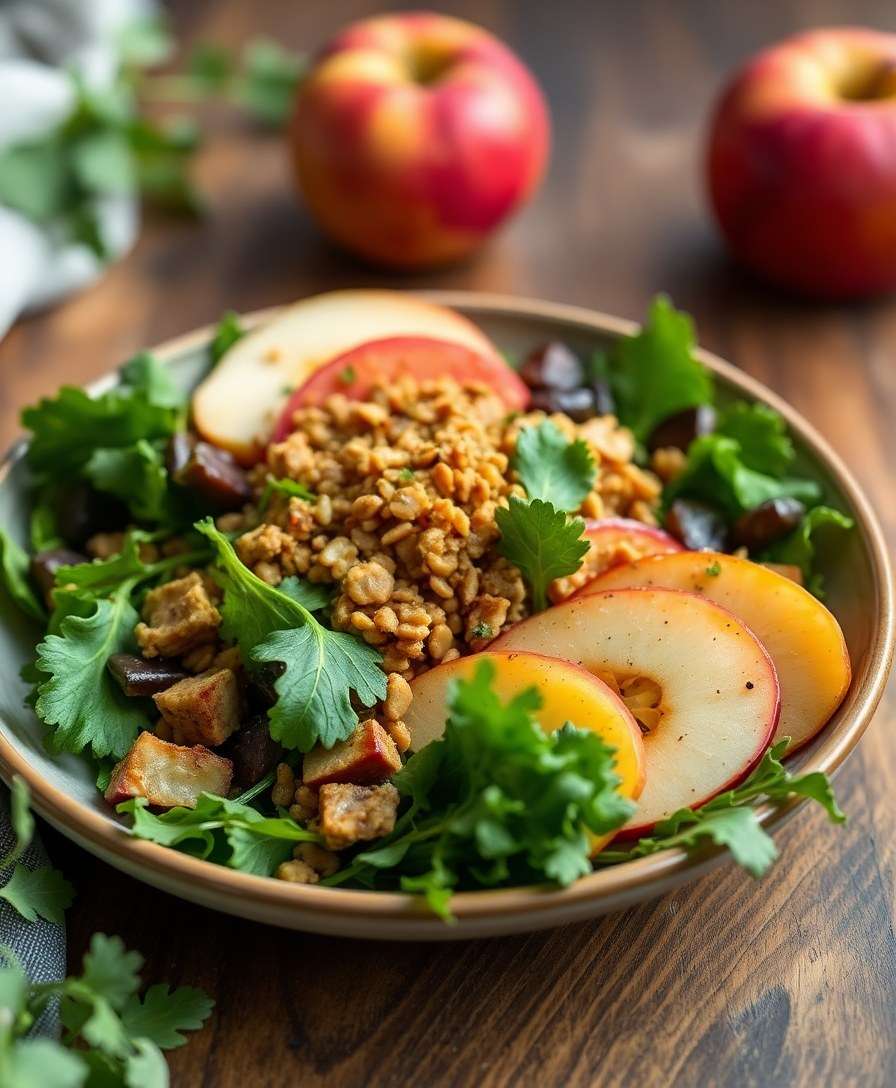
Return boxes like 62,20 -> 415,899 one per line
581,552 -> 851,754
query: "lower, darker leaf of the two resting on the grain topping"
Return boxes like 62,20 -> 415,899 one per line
495,496 -> 588,611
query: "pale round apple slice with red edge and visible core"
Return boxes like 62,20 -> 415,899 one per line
493,589 -> 779,838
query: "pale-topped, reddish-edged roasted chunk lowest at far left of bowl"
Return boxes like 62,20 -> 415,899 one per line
105,732 -> 234,808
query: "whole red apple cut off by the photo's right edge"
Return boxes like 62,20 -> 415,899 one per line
707,27 -> 896,298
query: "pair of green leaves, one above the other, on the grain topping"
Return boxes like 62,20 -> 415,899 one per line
495,419 -> 597,611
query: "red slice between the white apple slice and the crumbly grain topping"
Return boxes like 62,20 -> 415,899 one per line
274,336 -> 530,442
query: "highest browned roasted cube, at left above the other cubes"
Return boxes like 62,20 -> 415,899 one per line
134,571 -> 221,657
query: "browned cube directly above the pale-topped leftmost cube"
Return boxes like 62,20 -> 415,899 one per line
152,669 -> 240,747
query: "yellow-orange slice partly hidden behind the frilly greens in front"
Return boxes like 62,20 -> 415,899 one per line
405,650 -> 644,818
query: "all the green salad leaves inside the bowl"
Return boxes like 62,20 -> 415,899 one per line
0,297 -> 850,918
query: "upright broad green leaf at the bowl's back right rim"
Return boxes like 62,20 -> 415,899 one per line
595,295 -> 712,442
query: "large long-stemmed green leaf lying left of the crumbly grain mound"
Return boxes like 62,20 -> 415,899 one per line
197,520 -> 386,752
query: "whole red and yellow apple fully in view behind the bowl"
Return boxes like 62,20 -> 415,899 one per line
289,12 -> 549,269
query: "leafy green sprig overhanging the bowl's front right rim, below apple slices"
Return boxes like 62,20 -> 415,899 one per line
595,738 -> 846,877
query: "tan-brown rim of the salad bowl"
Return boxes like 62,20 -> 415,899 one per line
0,290 -> 896,938
